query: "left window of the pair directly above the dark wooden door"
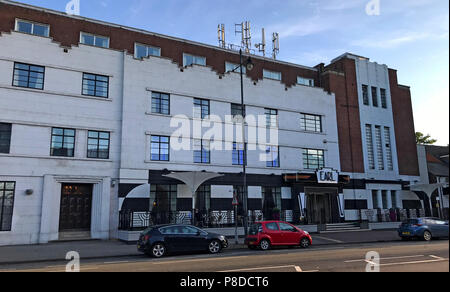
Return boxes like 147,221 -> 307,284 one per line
50,128 -> 75,157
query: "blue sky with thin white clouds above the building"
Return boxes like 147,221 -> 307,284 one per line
15,0 -> 449,145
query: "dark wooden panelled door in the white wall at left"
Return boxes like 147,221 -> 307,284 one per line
59,184 -> 93,231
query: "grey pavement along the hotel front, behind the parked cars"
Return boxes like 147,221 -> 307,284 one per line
0,230 -> 400,267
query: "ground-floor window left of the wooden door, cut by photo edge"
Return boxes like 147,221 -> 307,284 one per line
0,182 -> 16,231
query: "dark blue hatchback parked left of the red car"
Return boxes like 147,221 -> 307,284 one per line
137,225 -> 228,258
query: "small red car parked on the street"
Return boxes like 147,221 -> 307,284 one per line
245,221 -> 312,250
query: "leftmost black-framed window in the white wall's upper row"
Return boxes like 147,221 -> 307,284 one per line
13,63 -> 45,90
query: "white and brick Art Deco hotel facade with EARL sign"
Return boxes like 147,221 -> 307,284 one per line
0,1 -> 426,245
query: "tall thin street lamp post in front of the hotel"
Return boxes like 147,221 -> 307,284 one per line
233,49 -> 253,236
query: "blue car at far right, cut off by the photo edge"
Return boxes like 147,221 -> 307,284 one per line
398,218 -> 448,241
